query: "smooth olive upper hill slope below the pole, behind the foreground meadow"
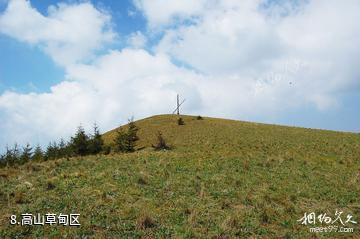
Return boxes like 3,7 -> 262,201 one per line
103,115 -> 360,158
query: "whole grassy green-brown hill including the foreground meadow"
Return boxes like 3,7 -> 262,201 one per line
0,115 -> 360,238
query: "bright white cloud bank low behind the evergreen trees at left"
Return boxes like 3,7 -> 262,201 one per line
0,49 -> 202,146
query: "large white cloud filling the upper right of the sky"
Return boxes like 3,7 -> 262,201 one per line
154,0 -> 360,109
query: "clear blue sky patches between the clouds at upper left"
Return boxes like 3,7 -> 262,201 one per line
0,0 -> 146,93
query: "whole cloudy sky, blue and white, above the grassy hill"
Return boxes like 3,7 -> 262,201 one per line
0,0 -> 360,148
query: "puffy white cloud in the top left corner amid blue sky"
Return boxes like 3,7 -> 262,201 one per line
0,0 -> 116,66
